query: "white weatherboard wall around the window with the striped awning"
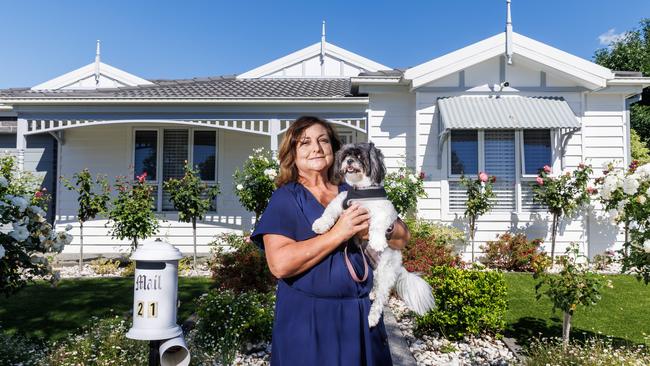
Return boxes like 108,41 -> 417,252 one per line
362,59 -> 628,256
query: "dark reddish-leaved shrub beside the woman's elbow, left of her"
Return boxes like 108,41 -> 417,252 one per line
210,233 -> 276,292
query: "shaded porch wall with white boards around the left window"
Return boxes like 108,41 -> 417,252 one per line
56,124 -> 270,253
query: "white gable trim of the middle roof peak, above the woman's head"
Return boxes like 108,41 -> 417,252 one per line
237,42 -> 390,79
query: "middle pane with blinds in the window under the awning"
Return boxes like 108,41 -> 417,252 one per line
484,130 -> 516,211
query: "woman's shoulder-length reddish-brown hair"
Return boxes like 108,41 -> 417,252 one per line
275,116 -> 341,187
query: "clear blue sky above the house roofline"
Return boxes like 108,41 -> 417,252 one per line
0,0 -> 650,88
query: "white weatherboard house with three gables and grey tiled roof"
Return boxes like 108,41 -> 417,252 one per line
0,17 -> 650,255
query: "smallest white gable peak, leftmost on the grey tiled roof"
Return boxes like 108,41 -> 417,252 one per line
32,62 -> 153,90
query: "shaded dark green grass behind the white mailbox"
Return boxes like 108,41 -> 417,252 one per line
0,277 -> 211,340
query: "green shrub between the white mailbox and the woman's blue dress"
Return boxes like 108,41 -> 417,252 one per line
189,290 -> 275,365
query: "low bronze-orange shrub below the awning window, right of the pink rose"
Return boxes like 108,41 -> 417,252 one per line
482,233 -> 550,272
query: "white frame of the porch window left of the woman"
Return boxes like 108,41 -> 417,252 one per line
131,126 -> 219,214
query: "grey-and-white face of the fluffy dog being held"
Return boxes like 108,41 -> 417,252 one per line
335,142 -> 386,188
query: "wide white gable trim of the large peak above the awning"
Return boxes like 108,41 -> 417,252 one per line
404,32 -> 614,89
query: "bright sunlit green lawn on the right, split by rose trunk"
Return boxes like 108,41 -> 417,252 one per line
505,273 -> 650,344
